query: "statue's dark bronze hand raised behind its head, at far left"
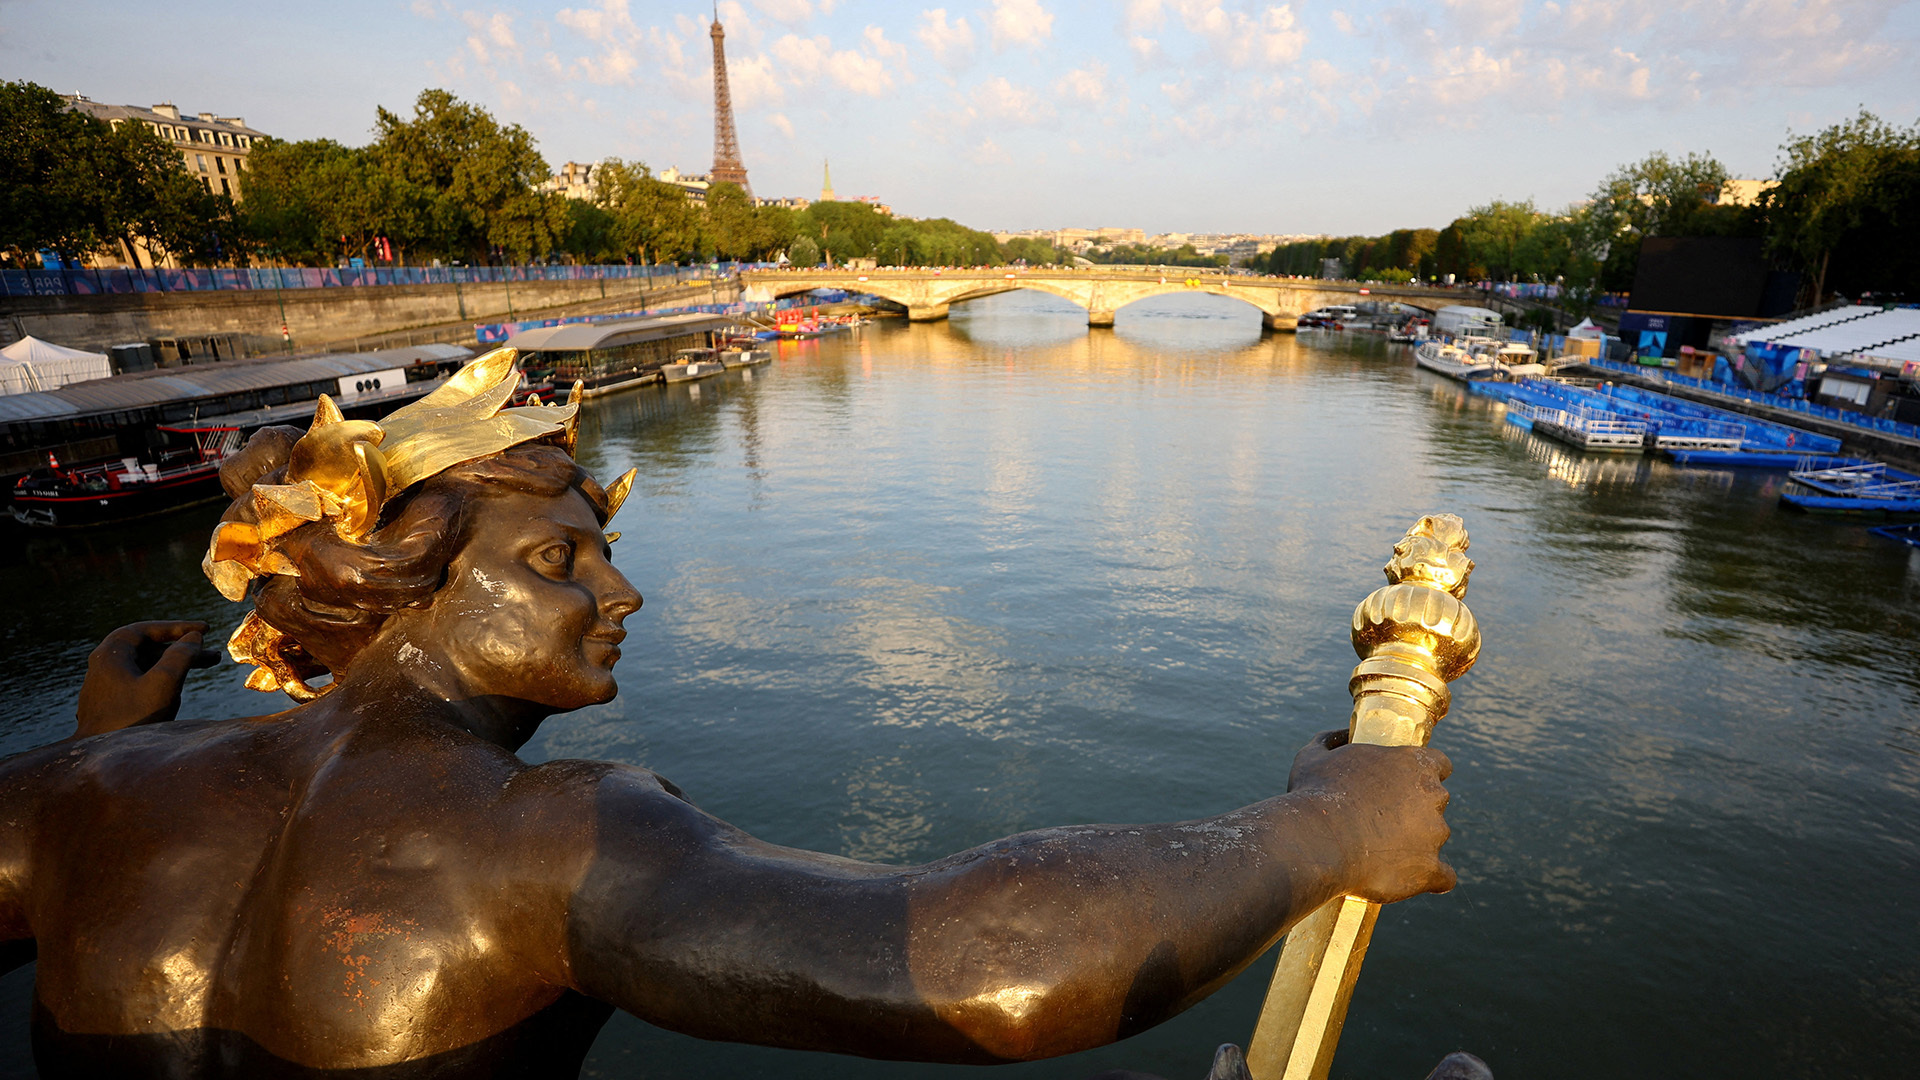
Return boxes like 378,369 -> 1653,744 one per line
73,621 -> 221,738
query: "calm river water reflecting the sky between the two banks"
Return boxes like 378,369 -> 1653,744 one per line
0,294 -> 1920,1080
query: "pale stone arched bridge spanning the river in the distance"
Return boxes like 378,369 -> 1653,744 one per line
739,267 -> 1478,331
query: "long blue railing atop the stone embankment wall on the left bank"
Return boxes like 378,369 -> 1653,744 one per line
0,263 -> 756,296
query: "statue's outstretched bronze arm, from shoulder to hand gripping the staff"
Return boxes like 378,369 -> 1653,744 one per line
568,732 -> 1453,1063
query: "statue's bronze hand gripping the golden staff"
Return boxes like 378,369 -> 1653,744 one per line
1286,730 -> 1455,903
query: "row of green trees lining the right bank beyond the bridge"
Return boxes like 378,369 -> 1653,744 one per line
1254,110 -> 1920,300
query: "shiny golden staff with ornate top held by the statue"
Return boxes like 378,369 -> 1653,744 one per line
1246,513 -> 1480,1080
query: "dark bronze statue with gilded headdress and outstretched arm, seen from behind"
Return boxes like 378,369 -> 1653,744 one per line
0,350 -> 1453,1078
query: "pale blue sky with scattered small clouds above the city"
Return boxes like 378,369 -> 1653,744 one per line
0,0 -> 1920,234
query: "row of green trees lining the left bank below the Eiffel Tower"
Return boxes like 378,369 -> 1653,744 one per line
0,83 -> 1069,265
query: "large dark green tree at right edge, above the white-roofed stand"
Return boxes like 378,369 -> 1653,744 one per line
1763,110 -> 1920,302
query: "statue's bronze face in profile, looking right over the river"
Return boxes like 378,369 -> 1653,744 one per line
399,490 -> 639,711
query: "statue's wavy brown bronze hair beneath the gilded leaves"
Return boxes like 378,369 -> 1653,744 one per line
221,427 -> 607,680
